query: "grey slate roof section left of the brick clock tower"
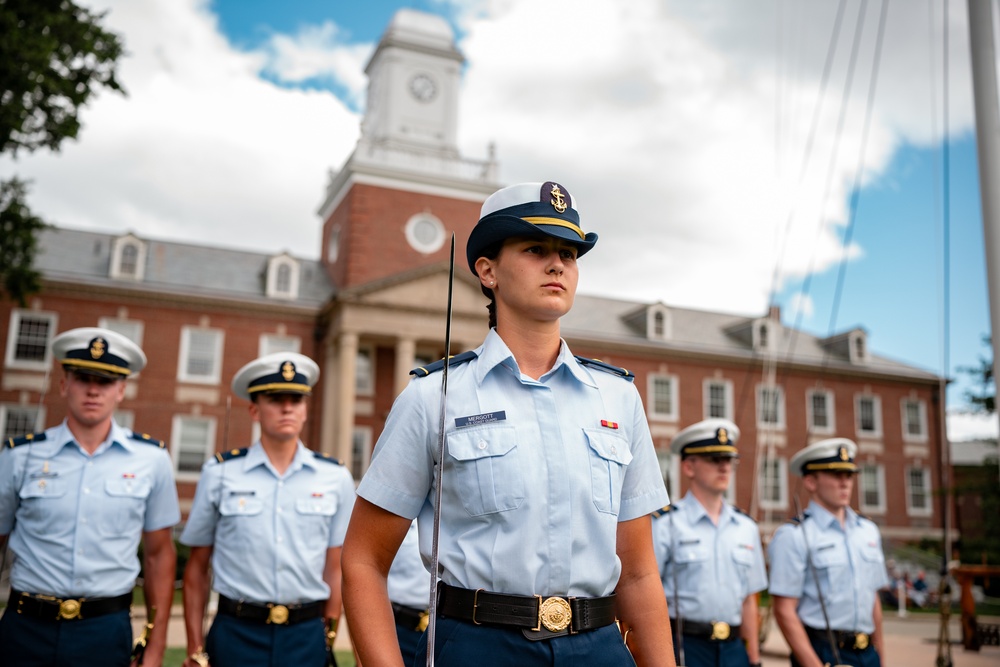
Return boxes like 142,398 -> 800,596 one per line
35,227 -> 335,309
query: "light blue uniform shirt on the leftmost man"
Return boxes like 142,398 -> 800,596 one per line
0,422 -> 180,598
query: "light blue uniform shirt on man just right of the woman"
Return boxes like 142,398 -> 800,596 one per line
653,492 -> 767,625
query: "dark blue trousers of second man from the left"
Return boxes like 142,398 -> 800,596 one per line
205,614 -> 326,667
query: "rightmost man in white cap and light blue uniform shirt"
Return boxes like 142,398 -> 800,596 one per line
768,438 -> 889,667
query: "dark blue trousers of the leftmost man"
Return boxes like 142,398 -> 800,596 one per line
0,607 -> 132,667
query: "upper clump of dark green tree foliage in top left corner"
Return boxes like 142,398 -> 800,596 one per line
0,0 -> 124,156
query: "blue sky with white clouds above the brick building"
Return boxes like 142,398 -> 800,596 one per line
0,0 -> 1000,439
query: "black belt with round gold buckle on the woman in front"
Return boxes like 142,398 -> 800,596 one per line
438,584 -> 616,639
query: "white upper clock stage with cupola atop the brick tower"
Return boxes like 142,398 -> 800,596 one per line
359,9 -> 464,157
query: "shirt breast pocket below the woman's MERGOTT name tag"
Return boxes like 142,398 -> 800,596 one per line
445,426 -> 524,516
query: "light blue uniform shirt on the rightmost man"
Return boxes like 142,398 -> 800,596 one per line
768,502 -> 889,634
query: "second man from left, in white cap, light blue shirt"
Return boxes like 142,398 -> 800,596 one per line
181,352 -> 354,667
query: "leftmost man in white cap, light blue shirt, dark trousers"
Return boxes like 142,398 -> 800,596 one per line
0,327 -> 180,667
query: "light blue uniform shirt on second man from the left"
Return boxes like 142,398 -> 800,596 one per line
181,441 -> 355,604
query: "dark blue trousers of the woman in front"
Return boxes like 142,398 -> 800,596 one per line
412,618 -> 635,667
